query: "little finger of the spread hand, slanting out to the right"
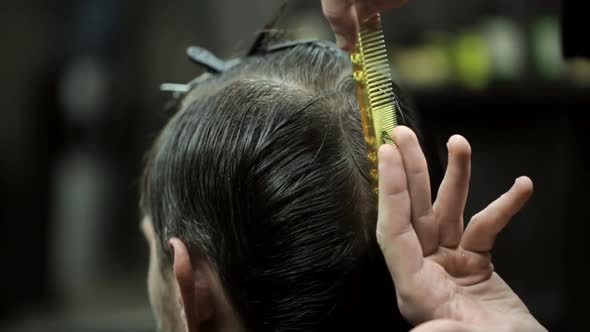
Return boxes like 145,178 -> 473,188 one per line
461,176 -> 533,252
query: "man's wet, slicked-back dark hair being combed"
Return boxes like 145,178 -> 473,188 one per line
142,42 -> 420,331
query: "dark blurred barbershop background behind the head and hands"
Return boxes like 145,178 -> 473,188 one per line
0,0 -> 590,331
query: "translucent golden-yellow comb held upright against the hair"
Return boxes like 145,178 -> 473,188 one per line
350,17 -> 397,192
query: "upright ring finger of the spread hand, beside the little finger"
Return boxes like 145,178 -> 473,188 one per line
434,135 -> 471,248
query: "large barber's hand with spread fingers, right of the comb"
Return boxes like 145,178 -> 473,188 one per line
377,126 -> 545,332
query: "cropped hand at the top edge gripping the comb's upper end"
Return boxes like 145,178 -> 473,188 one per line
322,0 -> 406,51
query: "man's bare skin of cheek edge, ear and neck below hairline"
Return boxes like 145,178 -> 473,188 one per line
141,217 -> 242,332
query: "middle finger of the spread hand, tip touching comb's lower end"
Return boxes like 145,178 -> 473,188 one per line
393,126 -> 438,256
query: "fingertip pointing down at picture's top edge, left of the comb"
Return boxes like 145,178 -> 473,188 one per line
322,0 -> 358,51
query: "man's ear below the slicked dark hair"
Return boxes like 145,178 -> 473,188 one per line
168,238 -> 217,332
